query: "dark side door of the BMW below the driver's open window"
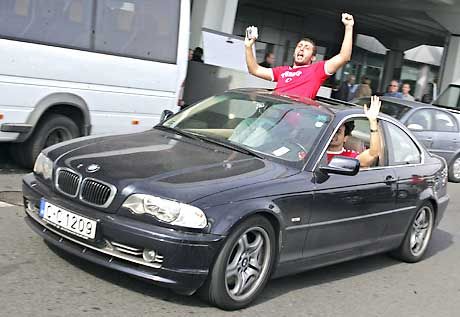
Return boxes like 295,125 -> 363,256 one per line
303,120 -> 396,261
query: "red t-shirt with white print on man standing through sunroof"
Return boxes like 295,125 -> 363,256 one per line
272,61 -> 331,99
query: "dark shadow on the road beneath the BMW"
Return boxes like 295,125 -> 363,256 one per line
42,229 -> 453,307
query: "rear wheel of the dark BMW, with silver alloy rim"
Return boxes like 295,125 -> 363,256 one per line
391,202 -> 435,263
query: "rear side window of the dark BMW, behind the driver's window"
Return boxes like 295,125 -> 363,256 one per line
384,122 -> 421,166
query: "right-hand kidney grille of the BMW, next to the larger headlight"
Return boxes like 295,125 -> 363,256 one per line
80,178 -> 115,207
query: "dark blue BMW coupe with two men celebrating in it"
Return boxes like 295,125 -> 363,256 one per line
23,89 -> 449,309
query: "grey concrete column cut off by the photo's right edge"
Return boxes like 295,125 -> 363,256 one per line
439,35 -> 460,91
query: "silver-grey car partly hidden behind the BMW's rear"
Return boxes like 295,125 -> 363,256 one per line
352,97 -> 460,183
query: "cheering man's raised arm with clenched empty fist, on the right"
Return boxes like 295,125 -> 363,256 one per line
326,13 -> 355,74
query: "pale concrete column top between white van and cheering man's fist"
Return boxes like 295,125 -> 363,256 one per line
190,0 -> 238,48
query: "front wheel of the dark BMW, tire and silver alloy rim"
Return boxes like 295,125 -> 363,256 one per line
200,216 -> 276,310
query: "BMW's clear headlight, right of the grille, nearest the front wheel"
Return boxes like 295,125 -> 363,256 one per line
123,194 -> 207,229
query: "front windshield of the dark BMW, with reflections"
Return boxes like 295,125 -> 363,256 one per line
163,93 -> 331,166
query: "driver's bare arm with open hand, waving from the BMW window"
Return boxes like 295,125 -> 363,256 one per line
358,96 -> 382,167
